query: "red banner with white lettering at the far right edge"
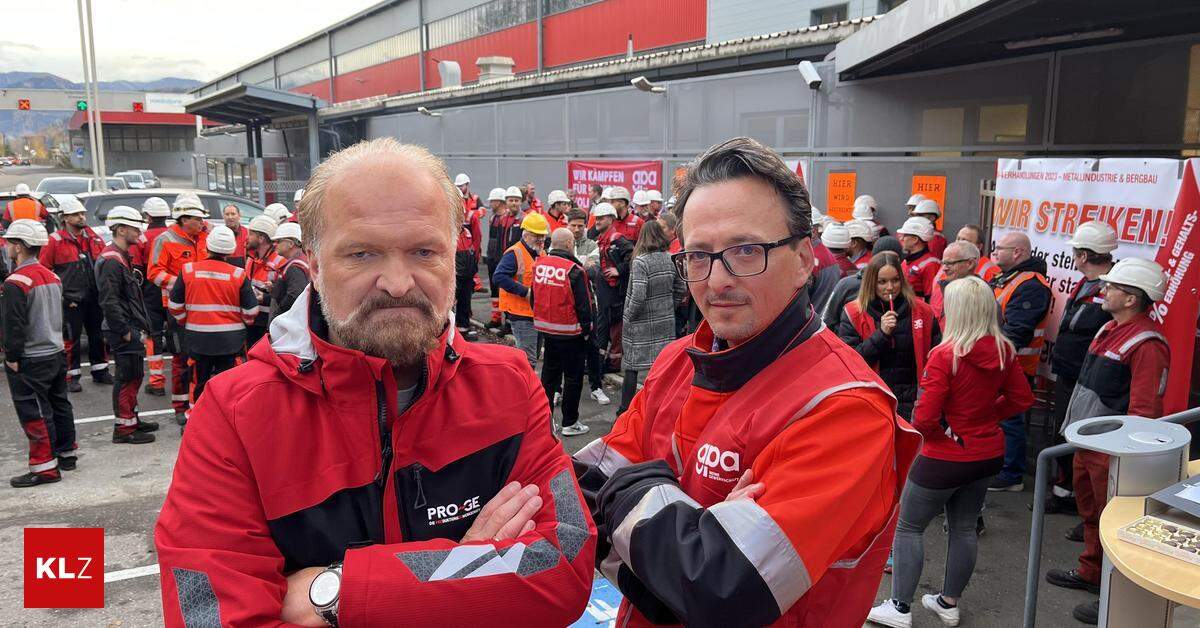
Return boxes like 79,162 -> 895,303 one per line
1151,160 -> 1200,414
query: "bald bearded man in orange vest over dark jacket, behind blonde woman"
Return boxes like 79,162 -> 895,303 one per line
988,232 -> 1054,491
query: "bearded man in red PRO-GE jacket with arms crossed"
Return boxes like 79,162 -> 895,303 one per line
155,137 -> 595,627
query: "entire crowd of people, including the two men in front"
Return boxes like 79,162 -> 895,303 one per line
0,138 -> 1169,628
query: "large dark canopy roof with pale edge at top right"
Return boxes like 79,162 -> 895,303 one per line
834,0 -> 1200,80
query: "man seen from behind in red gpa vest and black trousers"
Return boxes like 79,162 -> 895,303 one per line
530,225 -> 592,436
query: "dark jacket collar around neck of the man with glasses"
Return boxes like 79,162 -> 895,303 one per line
686,289 -> 823,393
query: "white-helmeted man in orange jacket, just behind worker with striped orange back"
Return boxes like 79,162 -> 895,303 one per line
146,192 -> 209,425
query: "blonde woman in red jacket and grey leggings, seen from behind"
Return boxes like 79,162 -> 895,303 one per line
868,276 -> 1033,628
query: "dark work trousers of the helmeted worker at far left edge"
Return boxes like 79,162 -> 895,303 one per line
5,353 -> 75,477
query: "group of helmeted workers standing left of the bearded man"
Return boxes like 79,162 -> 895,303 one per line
0,185 -> 308,488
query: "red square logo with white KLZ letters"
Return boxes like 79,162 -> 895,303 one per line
25,527 -> 104,609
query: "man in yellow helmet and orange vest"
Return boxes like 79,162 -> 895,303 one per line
492,211 -> 550,371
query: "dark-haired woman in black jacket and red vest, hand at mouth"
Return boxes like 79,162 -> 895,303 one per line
838,252 -> 941,419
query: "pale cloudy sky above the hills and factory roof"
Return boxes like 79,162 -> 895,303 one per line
0,0 -> 379,82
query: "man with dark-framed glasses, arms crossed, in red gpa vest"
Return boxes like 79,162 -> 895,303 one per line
576,138 -> 919,626
